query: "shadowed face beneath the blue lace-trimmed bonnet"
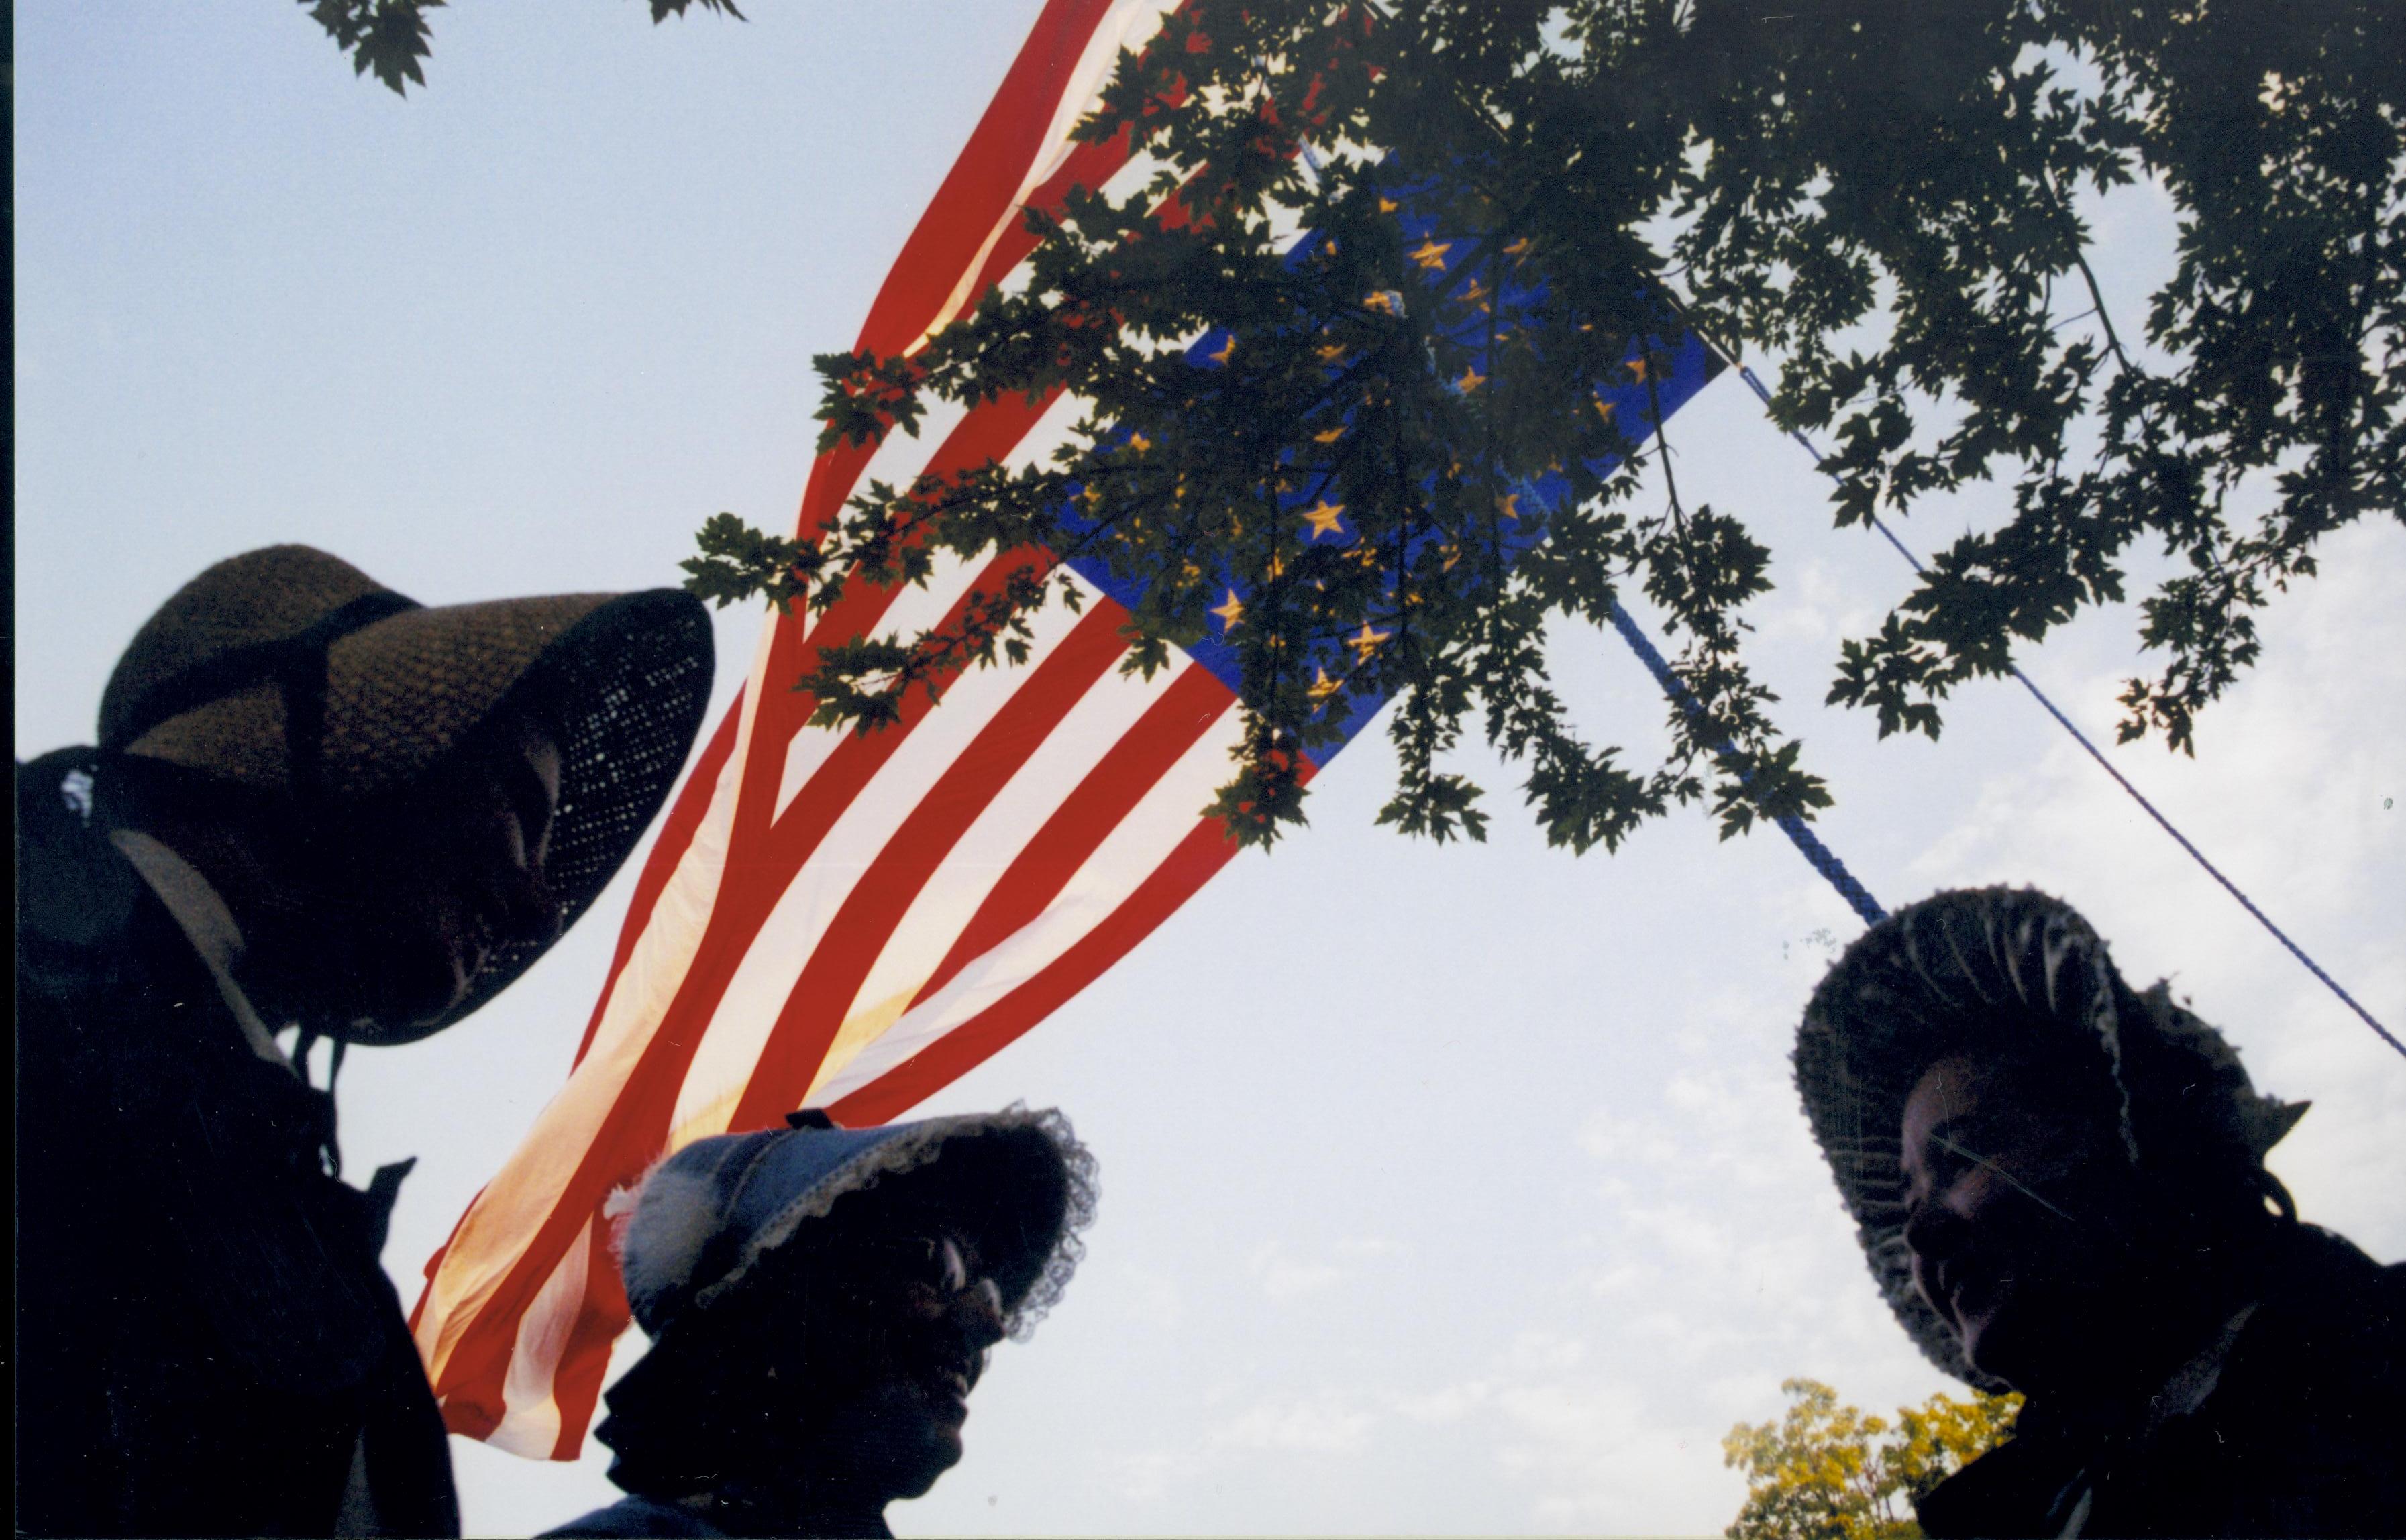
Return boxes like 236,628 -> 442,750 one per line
796,1227 -> 1003,1504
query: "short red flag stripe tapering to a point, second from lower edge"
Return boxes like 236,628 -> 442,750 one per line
912,664 -> 1237,1003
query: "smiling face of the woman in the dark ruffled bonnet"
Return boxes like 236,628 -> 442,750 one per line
1901,1054 -> 2144,1391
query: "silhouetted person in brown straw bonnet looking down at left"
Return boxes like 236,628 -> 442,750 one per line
17,546 -> 710,1535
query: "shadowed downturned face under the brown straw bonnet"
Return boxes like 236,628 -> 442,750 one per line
246,712 -> 561,1037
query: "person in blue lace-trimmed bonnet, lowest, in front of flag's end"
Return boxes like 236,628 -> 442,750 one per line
551,1111 -> 1095,1535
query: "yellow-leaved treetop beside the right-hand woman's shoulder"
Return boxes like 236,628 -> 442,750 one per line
1720,1379 -> 2021,1540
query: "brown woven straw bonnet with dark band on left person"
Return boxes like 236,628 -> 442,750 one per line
101,546 -> 712,1042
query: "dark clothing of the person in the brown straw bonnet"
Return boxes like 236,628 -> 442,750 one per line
17,751 -> 460,1535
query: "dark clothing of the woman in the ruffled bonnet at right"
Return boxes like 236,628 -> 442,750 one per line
1920,1225 -> 2406,1537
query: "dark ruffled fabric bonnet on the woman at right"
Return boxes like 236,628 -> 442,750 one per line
1795,888 -> 2305,1391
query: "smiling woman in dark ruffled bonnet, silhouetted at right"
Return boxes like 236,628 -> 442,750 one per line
1797,888 -> 2406,1535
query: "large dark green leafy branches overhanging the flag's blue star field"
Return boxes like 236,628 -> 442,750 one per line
688,0 -> 2406,849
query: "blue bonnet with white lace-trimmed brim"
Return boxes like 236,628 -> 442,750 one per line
619,1107 -> 1097,1338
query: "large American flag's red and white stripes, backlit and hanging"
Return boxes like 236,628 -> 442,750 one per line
411,0 -> 1706,1461
